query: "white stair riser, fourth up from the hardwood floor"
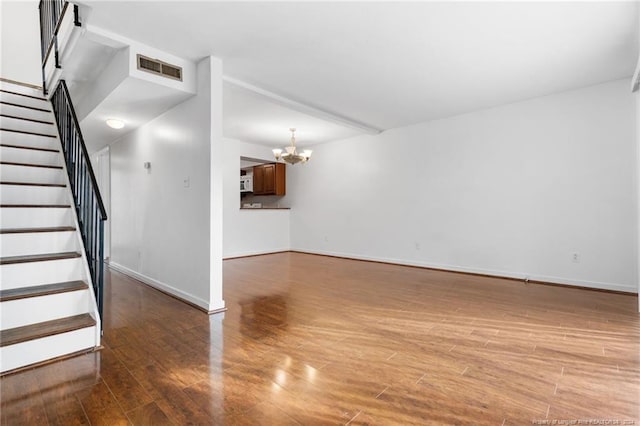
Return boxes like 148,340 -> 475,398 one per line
0,231 -> 80,257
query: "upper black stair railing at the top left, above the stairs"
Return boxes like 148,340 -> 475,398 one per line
38,0 -> 80,95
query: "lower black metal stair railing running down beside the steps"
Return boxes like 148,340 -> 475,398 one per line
51,80 -> 107,326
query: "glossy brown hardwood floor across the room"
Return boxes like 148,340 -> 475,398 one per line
0,253 -> 640,425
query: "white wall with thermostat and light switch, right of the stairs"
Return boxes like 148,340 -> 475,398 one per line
111,58 -> 212,309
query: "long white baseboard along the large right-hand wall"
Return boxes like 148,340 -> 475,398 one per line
291,248 -> 638,294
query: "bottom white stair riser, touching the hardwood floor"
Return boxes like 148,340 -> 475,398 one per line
0,326 -> 97,372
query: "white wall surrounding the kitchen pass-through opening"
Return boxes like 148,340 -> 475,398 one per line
223,138 -> 291,258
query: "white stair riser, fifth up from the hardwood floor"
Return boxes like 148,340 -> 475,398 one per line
0,208 -> 74,228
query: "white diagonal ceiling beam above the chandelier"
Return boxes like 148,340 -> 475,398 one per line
222,75 -> 384,135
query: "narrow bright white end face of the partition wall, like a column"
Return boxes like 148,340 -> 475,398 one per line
209,56 -> 225,313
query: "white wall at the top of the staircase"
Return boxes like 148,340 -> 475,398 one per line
0,1 -> 42,86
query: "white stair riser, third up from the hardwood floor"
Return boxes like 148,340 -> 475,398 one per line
0,257 -> 87,290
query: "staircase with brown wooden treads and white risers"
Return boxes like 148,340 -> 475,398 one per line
0,82 -> 100,374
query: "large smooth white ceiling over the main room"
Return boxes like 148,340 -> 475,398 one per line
79,1 -> 638,131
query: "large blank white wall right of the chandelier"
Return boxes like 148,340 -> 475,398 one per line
288,79 -> 638,292
